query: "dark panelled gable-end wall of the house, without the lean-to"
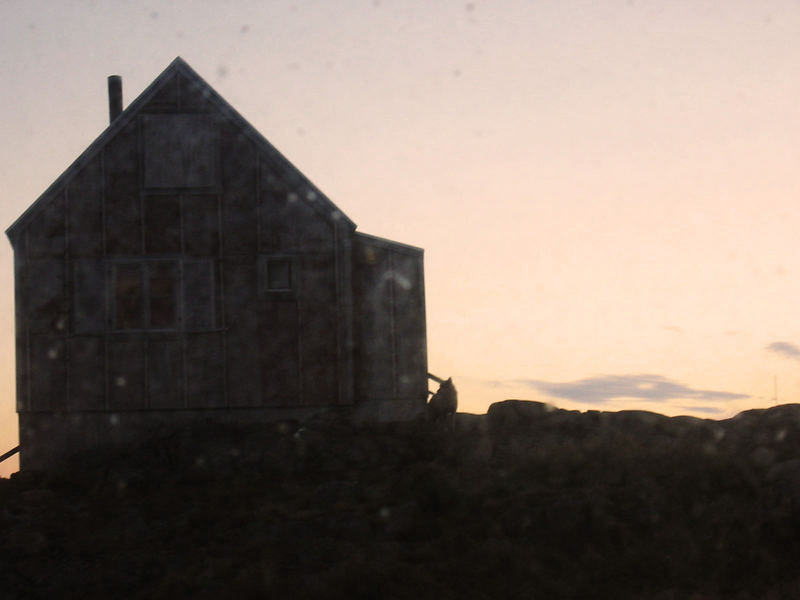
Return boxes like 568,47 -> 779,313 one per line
12,75 -> 352,472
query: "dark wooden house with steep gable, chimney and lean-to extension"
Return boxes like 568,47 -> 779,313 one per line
6,58 -> 427,469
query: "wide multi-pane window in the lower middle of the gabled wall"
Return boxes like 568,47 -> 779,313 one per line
111,260 -> 216,331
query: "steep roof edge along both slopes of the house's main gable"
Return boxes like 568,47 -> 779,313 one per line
6,56 -> 356,243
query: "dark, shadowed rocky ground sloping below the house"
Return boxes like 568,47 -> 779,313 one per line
0,401 -> 800,600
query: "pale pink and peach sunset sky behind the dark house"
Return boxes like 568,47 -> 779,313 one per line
0,0 -> 800,474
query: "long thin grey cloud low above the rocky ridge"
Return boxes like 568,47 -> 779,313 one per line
517,375 -> 749,404
